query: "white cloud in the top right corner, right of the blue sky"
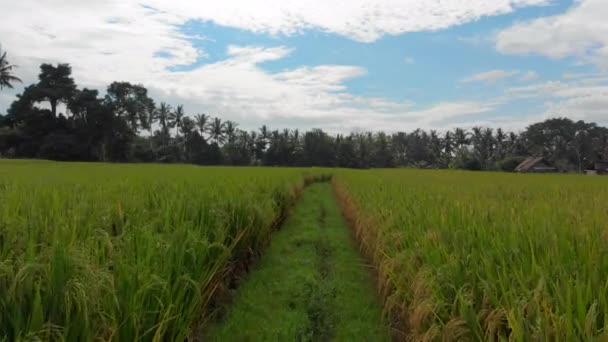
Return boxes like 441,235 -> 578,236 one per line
496,0 -> 608,68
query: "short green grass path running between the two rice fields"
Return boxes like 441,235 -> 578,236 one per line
208,183 -> 390,341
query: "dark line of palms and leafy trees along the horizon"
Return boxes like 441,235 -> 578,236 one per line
0,53 -> 608,171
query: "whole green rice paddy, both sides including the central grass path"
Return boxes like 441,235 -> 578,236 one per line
0,160 -> 608,341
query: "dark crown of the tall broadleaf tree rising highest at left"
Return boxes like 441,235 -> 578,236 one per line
36,64 -> 76,116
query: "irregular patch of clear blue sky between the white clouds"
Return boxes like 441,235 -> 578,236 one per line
174,0 -> 573,104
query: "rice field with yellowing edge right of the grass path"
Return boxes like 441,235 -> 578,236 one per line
334,170 -> 608,341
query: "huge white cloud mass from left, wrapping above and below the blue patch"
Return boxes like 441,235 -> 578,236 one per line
0,0 -> 549,131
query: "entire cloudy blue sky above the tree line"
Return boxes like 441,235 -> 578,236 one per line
0,0 -> 608,133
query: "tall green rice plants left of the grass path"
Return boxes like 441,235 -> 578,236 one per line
0,161 -> 318,341
